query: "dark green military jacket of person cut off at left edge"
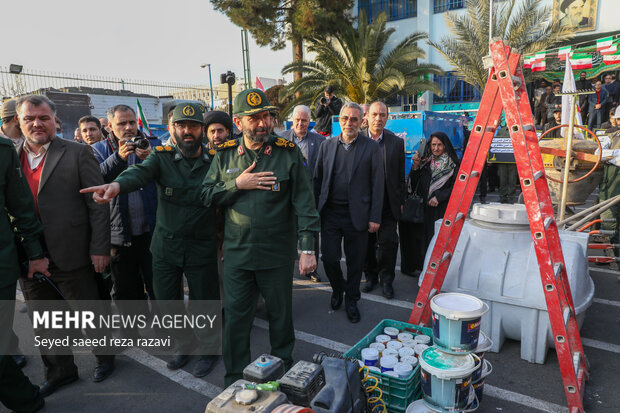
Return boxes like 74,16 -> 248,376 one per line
0,138 -> 43,287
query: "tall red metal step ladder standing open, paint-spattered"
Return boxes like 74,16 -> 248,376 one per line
409,41 -> 588,413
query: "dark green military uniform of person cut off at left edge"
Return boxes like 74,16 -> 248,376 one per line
0,138 -> 43,411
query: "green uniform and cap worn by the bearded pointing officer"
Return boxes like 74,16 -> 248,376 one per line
115,104 -> 220,355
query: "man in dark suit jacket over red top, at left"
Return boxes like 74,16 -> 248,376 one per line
17,95 -> 114,397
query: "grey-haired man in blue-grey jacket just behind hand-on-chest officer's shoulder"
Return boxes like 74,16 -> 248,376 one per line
280,105 -> 325,282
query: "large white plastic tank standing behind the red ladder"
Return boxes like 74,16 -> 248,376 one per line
420,203 -> 594,364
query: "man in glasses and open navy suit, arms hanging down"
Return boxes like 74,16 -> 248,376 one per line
314,103 -> 384,323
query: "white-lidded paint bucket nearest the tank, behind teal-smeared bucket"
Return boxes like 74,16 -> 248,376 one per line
431,293 -> 489,354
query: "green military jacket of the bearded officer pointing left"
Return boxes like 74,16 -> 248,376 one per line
114,145 -> 217,266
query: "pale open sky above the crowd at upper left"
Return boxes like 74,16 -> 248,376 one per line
0,0 -> 292,84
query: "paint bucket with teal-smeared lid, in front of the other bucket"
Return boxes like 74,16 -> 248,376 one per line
418,347 -> 476,411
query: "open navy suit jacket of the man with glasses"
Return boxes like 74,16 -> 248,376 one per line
314,134 -> 384,231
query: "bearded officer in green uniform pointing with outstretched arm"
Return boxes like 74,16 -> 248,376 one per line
82,103 -> 220,377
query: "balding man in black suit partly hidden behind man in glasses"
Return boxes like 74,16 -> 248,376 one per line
362,102 -> 406,298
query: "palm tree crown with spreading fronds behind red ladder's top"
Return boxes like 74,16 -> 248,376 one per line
429,0 -> 572,91
